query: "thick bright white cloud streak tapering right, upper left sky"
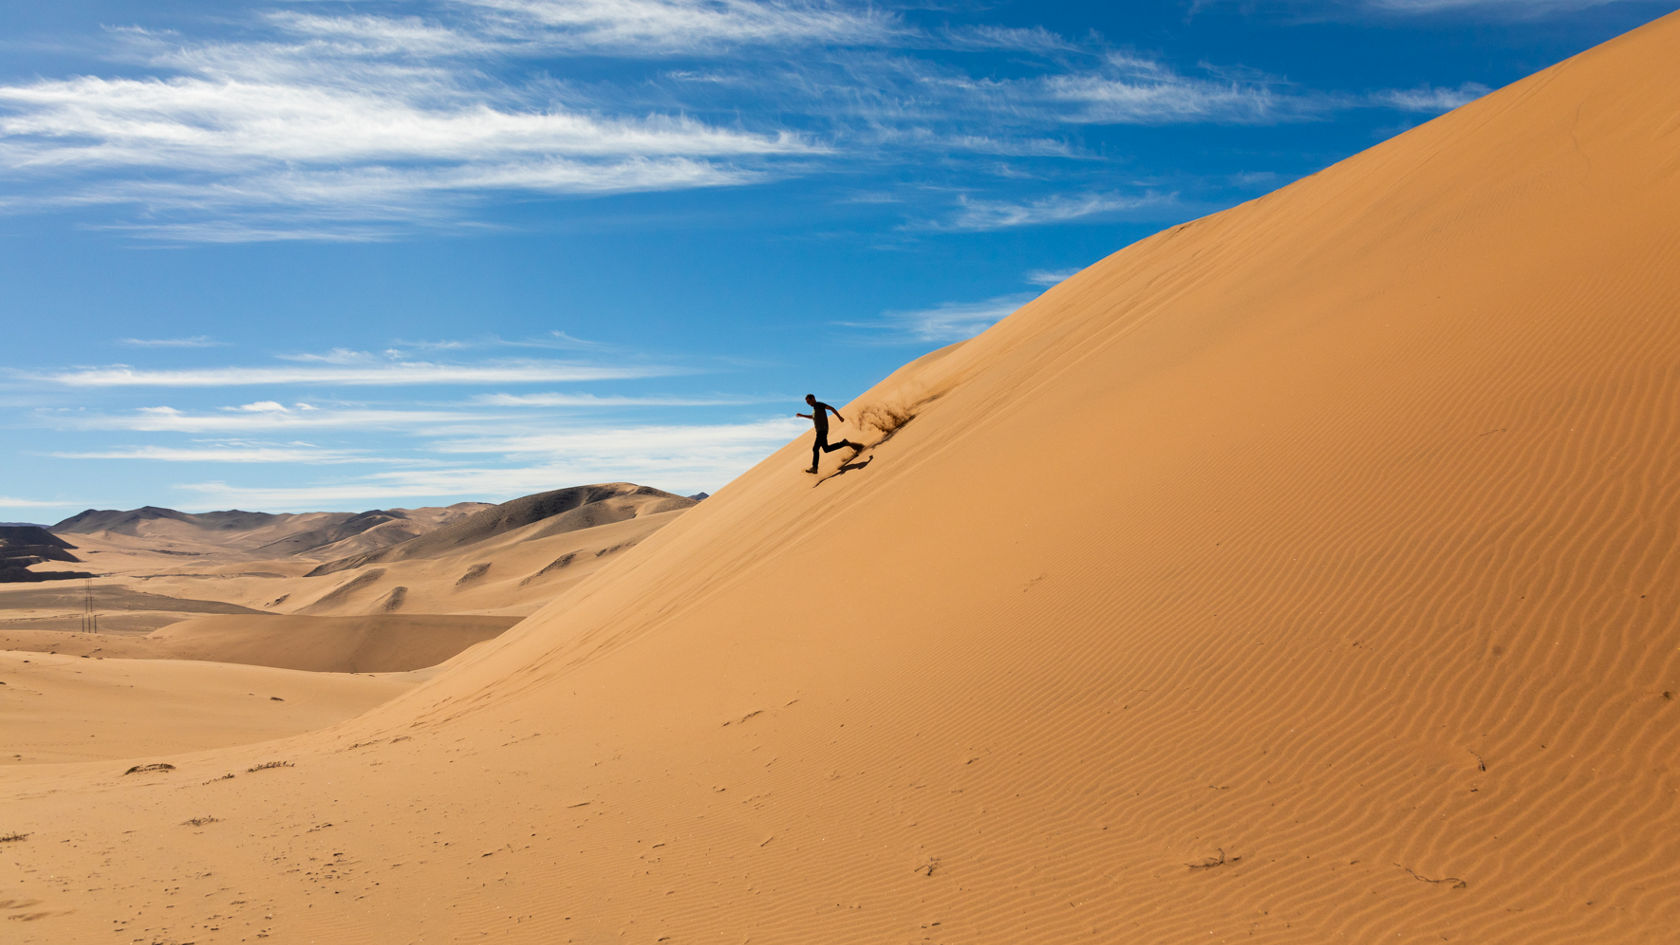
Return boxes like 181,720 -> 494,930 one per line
0,76 -> 806,169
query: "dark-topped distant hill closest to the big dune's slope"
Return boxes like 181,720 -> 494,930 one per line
306,483 -> 694,577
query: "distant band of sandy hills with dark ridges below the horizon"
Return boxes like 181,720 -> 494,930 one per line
11,483 -> 694,631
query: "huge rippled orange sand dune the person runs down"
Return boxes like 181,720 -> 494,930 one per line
0,15 -> 1680,945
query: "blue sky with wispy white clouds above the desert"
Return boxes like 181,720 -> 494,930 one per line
0,0 -> 1672,521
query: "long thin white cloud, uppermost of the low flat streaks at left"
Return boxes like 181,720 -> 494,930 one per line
37,362 -> 685,387
